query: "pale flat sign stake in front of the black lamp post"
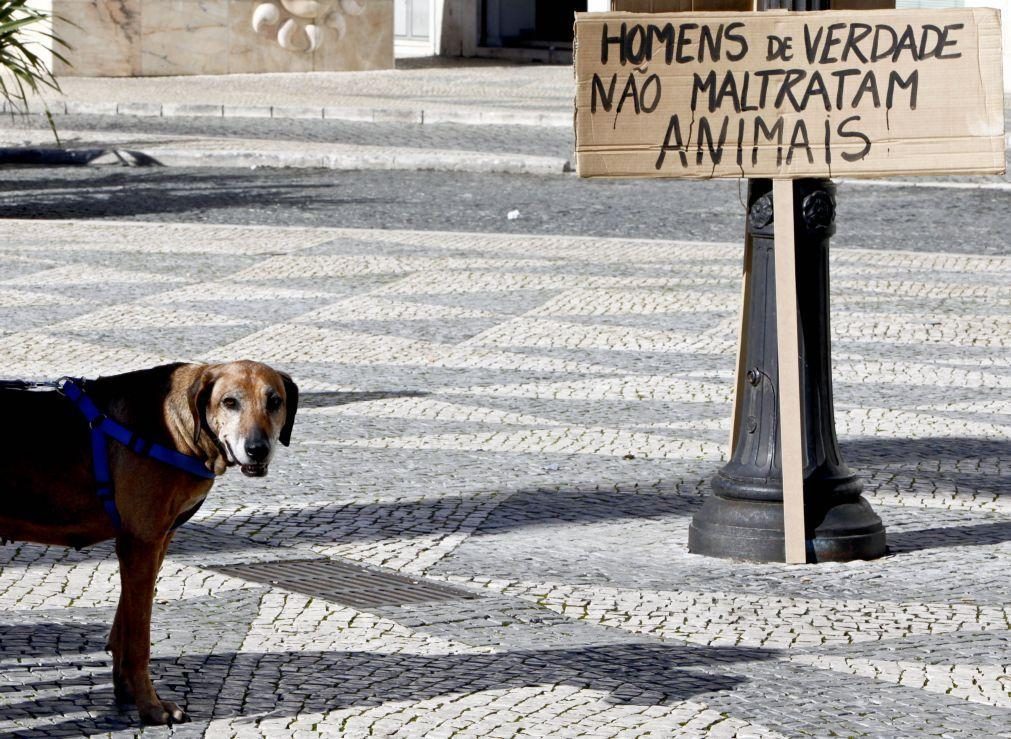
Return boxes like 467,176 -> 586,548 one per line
772,180 -> 807,564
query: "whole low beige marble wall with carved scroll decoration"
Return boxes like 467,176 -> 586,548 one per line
46,0 -> 393,77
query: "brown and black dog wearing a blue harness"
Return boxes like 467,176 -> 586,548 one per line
0,361 -> 298,724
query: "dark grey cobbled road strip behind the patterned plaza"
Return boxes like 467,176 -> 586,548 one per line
0,167 -> 1011,256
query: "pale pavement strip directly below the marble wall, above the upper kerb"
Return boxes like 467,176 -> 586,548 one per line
23,58 -> 572,126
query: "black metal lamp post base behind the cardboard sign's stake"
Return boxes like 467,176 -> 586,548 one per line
688,180 -> 885,562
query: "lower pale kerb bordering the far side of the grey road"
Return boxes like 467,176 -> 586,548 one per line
0,147 -> 572,175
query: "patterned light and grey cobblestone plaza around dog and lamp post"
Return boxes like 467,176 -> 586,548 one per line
0,220 -> 1011,739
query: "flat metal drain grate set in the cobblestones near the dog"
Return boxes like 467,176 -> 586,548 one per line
207,559 -> 476,609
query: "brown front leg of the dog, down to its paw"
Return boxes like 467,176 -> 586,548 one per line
109,534 -> 189,725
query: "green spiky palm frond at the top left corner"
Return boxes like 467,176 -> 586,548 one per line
0,0 -> 70,142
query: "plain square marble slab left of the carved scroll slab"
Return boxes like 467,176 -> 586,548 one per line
141,0 -> 229,76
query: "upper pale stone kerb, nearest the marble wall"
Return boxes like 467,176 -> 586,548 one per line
0,100 -> 572,127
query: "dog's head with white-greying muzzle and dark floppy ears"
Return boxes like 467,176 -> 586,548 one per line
187,360 -> 298,477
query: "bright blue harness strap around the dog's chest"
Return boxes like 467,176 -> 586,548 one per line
58,377 -> 215,531
